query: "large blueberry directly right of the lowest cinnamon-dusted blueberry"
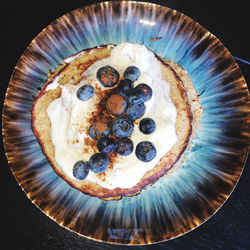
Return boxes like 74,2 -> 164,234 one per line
112,116 -> 134,138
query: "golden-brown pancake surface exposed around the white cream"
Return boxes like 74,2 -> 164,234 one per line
31,42 -> 202,200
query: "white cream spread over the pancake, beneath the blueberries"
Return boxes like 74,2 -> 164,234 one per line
46,43 -> 177,189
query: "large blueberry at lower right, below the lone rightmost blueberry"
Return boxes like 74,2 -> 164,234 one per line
135,141 -> 156,162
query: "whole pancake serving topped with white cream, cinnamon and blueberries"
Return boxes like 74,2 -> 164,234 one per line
31,43 -> 202,200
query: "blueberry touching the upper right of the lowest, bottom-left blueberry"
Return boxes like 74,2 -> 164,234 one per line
89,153 -> 109,174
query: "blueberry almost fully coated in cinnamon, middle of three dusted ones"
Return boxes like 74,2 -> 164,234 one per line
106,94 -> 127,116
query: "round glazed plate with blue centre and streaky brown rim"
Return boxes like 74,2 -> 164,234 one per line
3,1 -> 249,245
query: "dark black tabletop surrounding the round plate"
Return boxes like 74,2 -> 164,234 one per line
0,0 -> 250,250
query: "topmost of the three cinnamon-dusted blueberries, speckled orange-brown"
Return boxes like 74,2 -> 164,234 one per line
96,66 -> 120,87
